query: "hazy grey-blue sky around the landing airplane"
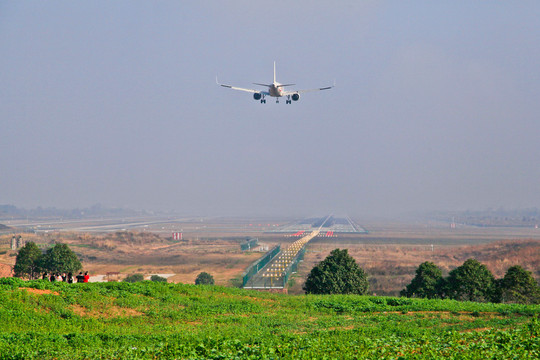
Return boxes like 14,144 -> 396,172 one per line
0,0 -> 540,216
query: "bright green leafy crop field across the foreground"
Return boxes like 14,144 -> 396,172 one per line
0,278 -> 540,360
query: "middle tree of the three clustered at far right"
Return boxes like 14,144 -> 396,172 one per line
445,259 -> 495,302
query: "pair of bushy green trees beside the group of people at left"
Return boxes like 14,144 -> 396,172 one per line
13,241 -> 82,280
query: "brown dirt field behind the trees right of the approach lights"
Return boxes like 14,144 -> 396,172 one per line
289,240 -> 540,295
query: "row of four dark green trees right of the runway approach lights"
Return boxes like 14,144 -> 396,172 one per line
303,249 -> 540,304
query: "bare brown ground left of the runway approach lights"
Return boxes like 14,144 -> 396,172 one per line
0,232 -> 276,286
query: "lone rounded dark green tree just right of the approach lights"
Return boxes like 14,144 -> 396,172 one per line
303,249 -> 369,295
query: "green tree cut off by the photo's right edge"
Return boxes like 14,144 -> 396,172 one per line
497,265 -> 540,304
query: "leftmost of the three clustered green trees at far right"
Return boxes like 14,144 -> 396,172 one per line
401,261 -> 443,299
